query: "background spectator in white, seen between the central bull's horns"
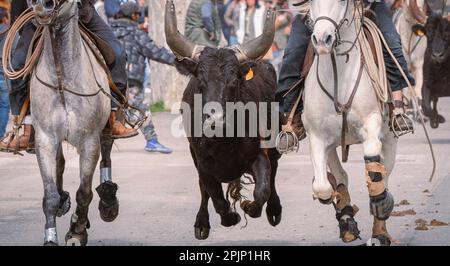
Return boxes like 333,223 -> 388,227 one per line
236,0 -> 266,44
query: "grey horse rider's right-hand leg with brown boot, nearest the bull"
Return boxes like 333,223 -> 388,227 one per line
83,4 -> 138,138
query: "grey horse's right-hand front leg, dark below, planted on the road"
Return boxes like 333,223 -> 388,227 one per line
66,135 -> 100,246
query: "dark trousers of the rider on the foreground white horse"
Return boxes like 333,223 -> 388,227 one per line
276,0 -> 415,113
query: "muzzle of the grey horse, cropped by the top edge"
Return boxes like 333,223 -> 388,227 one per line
27,0 -> 80,25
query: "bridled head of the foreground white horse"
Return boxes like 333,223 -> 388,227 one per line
310,0 -> 352,54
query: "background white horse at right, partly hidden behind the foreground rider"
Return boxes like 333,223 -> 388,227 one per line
394,0 -> 427,116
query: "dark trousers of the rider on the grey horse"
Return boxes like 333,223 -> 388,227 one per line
9,5 -> 127,115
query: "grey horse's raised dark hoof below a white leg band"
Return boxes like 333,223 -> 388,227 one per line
95,181 -> 119,222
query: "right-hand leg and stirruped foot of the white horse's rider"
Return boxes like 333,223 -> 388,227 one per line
372,1 -> 415,132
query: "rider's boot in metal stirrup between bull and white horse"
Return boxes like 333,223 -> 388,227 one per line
277,112 -> 306,154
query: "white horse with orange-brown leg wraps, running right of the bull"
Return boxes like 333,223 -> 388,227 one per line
302,0 -> 397,244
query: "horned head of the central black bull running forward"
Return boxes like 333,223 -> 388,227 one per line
165,0 -> 275,129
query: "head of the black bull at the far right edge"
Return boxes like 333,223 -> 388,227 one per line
425,1 -> 450,63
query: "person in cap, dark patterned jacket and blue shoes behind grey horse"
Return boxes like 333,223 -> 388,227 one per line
110,2 -> 175,153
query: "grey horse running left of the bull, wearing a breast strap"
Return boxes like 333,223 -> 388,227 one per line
28,0 -> 118,245
